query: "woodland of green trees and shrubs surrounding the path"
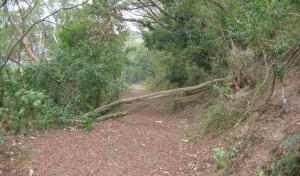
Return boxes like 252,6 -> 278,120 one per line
0,0 -> 300,175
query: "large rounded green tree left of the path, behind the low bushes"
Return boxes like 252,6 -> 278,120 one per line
24,8 -> 127,114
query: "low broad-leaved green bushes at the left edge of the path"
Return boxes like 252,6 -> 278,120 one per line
0,66 -> 70,135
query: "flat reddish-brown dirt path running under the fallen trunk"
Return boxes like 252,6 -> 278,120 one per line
6,87 -> 197,176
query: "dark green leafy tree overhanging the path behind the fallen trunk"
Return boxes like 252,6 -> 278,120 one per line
143,0 -> 225,87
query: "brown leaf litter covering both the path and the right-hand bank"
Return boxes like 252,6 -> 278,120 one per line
0,70 -> 300,176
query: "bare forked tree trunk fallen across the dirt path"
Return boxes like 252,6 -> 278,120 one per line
72,76 -> 232,122
